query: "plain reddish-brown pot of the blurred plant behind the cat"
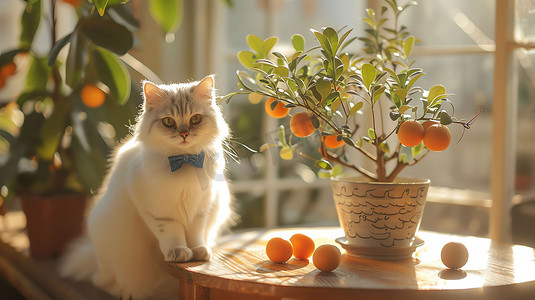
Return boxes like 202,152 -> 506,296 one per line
20,194 -> 87,259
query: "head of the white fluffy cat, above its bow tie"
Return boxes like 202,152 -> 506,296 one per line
136,76 -> 228,155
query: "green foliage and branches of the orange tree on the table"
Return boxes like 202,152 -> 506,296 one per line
222,0 -> 475,182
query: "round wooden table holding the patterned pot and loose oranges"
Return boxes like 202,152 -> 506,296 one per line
169,228 -> 535,300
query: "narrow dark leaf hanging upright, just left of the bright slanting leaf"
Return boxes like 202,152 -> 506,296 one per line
65,32 -> 87,88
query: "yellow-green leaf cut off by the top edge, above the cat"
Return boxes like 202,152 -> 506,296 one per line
149,0 -> 184,33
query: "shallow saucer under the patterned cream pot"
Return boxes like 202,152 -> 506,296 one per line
335,236 -> 424,260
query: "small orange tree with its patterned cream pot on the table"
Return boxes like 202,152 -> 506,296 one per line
222,0 -> 473,254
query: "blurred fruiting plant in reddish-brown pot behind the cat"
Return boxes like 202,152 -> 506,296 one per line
0,0 -> 181,258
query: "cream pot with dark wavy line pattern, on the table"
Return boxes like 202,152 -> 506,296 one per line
332,178 -> 430,248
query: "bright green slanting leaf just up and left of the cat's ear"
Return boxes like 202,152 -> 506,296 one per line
93,47 -> 131,105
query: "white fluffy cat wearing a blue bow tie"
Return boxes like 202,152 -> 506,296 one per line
60,76 -> 231,299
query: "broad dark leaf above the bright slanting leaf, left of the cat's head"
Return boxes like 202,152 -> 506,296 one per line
79,17 -> 134,55
